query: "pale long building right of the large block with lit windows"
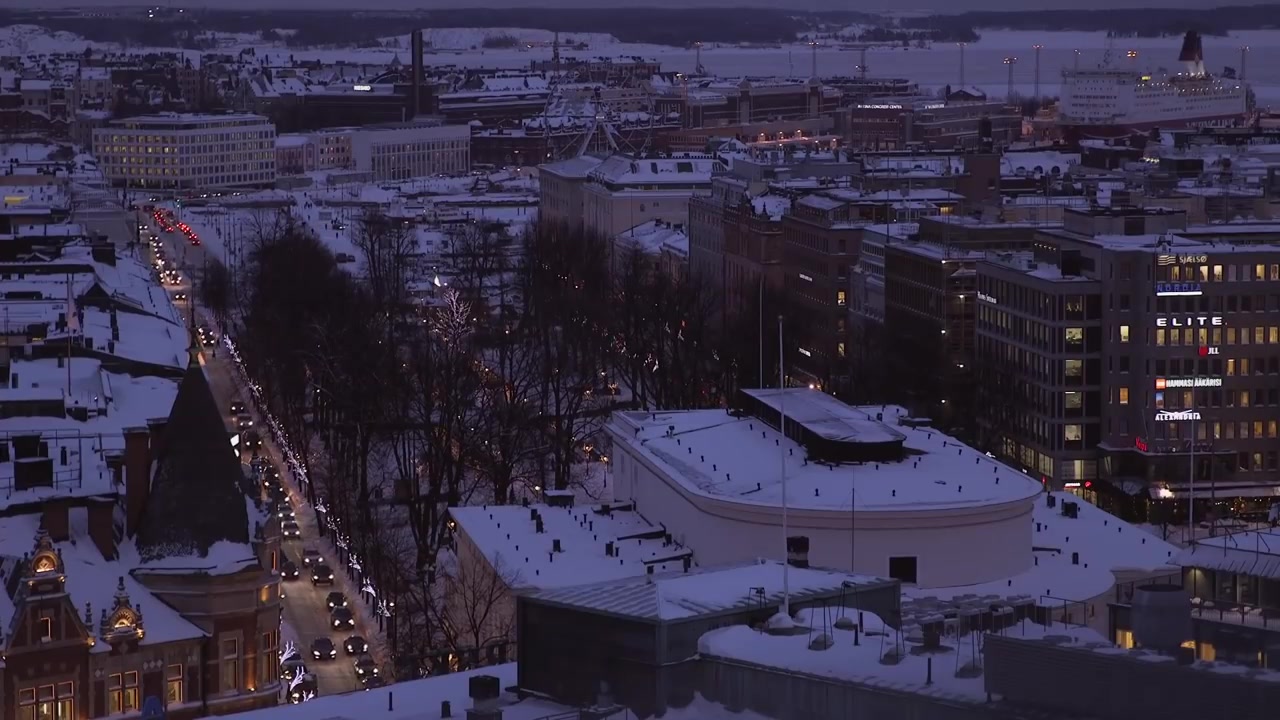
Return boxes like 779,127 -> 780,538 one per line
351,124 -> 471,181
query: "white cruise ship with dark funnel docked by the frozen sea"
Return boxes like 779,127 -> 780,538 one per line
1057,31 -> 1248,140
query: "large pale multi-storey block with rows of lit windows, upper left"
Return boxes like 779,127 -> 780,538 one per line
93,113 -> 275,190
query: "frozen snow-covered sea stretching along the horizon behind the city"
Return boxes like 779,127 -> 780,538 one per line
0,26 -> 1280,106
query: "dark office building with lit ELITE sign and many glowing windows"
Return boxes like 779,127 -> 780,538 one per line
977,208 -> 1280,518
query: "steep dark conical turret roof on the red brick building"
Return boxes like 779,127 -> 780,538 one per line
137,359 -> 250,561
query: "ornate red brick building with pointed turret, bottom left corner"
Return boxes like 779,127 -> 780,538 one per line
0,351 -> 280,720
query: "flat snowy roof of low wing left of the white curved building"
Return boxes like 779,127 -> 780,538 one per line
449,505 -> 692,588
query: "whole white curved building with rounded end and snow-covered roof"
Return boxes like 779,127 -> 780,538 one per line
608,389 -> 1043,592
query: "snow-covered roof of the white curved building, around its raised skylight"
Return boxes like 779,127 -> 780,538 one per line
611,389 -> 1041,512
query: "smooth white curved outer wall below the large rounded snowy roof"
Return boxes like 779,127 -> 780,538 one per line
609,425 -> 1033,588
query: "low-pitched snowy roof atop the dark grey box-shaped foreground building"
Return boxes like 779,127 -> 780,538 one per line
529,560 -> 895,620
